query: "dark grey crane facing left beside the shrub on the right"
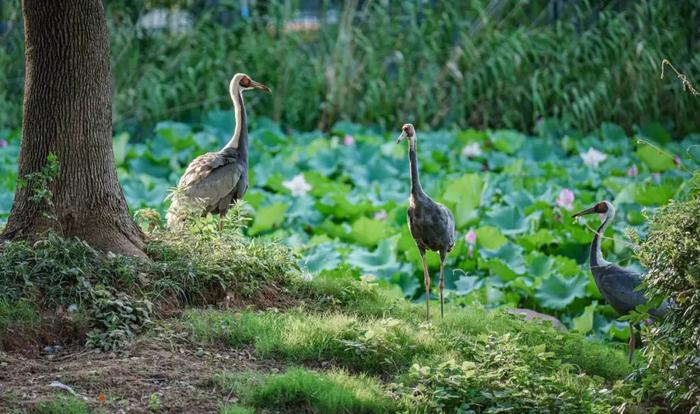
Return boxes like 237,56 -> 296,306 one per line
572,201 -> 668,362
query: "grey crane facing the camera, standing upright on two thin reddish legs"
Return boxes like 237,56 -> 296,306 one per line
396,124 -> 455,320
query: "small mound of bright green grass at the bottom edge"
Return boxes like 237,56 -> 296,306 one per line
217,368 -> 395,414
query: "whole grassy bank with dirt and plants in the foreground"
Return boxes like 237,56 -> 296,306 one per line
0,228 -> 631,413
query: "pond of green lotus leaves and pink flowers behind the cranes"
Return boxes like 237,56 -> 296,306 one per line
0,115 -> 700,340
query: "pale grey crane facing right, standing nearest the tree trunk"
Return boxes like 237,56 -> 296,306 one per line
166,73 -> 270,230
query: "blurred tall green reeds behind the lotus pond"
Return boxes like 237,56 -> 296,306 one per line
0,0 -> 700,137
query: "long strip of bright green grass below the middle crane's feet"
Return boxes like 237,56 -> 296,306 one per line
184,272 -> 630,380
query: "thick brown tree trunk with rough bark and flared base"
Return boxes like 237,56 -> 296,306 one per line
2,0 -> 145,256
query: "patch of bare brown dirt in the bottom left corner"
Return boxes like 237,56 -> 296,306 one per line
0,337 -> 281,413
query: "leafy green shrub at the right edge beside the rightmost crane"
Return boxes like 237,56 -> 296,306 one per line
638,173 -> 700,413
